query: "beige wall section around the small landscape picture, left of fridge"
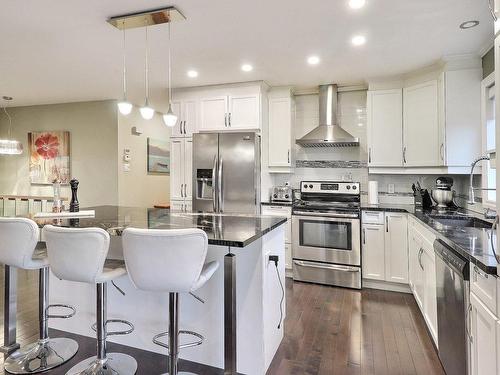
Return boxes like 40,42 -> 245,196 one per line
118,107 -> 170,207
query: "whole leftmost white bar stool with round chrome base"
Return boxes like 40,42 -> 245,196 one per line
0,217 -> 78,374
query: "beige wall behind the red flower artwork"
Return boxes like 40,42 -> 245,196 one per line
0,101 -> 118,206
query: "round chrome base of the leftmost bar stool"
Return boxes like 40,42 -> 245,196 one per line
4,337 -> 78,374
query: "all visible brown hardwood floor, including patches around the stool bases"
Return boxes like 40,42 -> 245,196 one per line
0,268 -> 444,375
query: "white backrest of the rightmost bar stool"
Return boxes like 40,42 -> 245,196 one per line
122,228 -> 208,293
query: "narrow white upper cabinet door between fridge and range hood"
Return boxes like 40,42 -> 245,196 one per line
268,89 -> 295,172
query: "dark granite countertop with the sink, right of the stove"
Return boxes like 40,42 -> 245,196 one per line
362,204 -> 498,275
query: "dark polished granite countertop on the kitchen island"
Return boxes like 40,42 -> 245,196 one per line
31,206 -> 286,247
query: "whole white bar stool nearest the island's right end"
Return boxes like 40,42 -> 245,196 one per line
122,228 -> 219,375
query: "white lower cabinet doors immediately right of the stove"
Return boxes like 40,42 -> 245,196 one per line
362,212 -> 408,284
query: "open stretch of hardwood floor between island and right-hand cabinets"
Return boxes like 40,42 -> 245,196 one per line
267,279 -> 445,375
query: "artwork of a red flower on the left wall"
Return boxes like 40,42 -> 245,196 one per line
28,130 -> 71,184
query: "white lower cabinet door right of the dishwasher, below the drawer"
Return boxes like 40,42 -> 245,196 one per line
470,293 -> 497,375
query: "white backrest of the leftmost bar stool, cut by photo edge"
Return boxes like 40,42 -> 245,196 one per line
0,217 -> 40,269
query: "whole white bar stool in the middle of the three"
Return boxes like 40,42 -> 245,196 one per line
43,225 -> 137,375
